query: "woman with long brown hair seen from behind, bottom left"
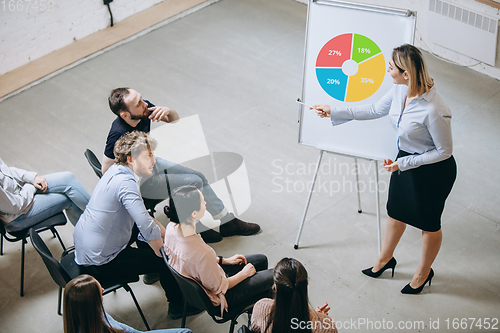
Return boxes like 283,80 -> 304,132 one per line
63,274 -> 191,333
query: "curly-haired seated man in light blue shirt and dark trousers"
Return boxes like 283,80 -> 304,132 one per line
73,131 -> 200,317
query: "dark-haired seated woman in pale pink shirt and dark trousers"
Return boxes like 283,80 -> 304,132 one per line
164,185 -> 273,316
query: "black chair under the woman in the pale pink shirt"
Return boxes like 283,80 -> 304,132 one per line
160,247 -> 258,333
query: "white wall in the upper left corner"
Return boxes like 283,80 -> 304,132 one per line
0,0 -> 163,75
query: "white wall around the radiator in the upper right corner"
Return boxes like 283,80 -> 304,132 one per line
297,0 -> 500,79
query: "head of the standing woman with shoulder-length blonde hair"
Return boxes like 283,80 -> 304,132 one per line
392,44 -> 434,97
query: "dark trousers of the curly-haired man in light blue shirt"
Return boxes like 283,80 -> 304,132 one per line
81,226 -> 184,306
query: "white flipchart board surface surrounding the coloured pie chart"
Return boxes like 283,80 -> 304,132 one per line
299,0 -> 416,160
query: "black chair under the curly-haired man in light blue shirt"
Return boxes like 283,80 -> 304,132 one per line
29,228 -> 150,331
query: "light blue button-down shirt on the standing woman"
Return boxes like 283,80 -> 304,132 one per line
331,85 -> 453,171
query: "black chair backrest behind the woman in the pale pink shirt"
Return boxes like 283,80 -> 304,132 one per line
160,247 -> 220,317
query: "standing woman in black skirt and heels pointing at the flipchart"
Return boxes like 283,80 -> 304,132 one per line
314,44 -> 457,294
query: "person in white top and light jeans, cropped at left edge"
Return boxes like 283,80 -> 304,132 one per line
0,159 -> 90,232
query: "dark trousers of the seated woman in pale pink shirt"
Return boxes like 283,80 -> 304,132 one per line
221,254 -> 273,308
